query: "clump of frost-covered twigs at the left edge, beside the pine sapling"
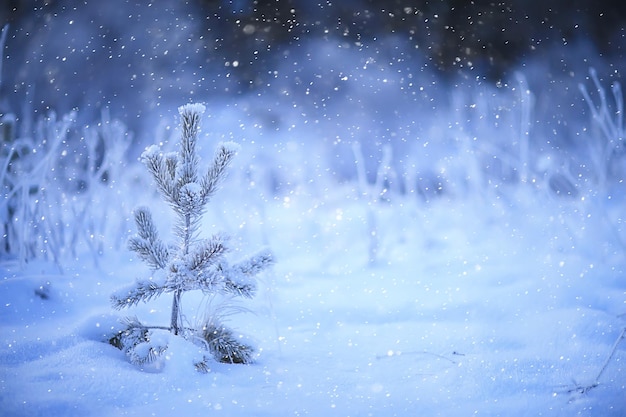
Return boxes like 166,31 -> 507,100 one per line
0,105 -> 129,270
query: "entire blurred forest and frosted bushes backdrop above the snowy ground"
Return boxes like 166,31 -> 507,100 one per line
0,0 -> 626,266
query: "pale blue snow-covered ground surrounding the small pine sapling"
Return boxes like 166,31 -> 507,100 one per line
0,184 -> 626,417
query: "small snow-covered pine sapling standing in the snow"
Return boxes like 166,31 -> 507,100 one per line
110,104 -> 273,370
